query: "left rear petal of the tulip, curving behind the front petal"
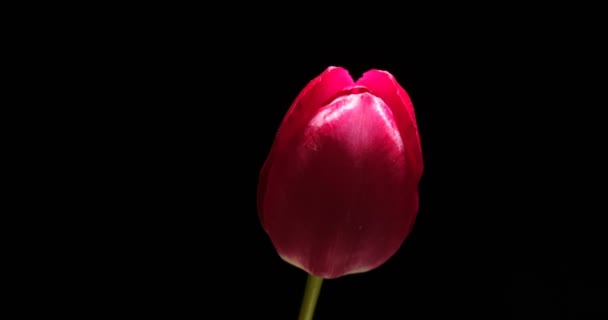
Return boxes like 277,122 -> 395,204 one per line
257,67 -> 354,223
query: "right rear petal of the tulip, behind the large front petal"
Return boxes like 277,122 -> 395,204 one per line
356,69 -> 423,183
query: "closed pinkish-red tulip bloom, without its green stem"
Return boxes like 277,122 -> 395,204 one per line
257,67 -> 423,279
